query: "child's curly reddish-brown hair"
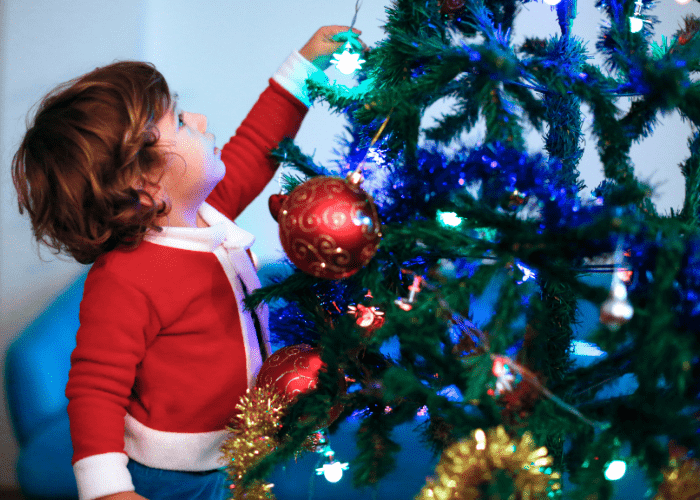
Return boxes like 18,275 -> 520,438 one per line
12,61 -> 172,264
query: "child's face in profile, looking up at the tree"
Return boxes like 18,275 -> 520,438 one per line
156,105 -> 226,208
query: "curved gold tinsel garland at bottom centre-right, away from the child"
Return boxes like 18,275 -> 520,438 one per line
416,426 -> 561,500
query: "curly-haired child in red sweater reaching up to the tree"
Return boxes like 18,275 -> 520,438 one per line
12,26 -> 366,500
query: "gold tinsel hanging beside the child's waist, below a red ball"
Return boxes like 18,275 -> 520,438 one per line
221,387 -> 290,500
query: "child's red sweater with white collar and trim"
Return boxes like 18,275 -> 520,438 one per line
66,54 -> 318,500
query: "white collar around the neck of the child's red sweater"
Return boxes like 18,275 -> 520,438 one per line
144,203 -> 255,252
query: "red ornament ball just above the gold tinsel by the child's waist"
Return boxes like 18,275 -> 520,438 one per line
255,344 -> 347,426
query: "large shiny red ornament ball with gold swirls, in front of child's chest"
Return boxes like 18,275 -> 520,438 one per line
277,176 -> 381,280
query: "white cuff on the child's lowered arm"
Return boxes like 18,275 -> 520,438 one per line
73,452 -> 134,500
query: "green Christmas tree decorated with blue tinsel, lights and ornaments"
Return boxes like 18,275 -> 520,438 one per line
221,0 -> 700,499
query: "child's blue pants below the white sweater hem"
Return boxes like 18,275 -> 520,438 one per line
127,460 -> 230,500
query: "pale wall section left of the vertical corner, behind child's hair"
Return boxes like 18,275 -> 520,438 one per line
0,0 -> 149,485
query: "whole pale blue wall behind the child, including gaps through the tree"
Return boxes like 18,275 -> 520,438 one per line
0,0 -> 700,486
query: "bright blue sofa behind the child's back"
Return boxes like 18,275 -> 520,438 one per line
5,274 -> 86,500
